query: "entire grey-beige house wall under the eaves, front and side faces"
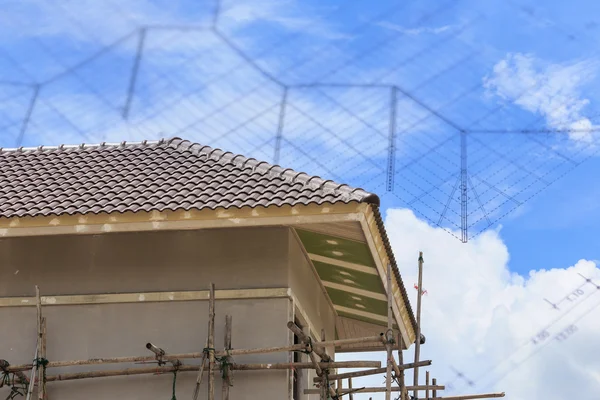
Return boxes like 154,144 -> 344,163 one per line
0,228 -> 318,400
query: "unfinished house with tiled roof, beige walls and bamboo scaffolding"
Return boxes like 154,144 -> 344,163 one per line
0,138 -> 503,400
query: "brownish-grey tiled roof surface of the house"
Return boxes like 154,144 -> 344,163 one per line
0,138 -> 379,218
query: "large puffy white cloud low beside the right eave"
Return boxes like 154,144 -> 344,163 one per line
344,209 -> 600,400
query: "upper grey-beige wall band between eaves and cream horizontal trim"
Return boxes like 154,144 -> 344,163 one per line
0,228 -> 289,296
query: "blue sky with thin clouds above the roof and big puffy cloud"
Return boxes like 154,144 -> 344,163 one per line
0,0 -> 600,399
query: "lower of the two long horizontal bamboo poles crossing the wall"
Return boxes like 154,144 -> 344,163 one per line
41,361 -> 381,382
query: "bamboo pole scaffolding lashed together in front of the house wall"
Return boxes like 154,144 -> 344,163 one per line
0,253 -> 504,400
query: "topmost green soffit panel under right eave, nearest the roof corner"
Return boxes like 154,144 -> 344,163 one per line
296,229 -> 375,268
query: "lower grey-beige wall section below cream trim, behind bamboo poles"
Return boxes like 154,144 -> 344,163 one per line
0,299 -> 291,400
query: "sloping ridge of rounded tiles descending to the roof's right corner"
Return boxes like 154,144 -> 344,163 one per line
166,137 -> 380,205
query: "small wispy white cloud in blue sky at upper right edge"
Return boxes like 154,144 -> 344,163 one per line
484,53 -> 598,142
